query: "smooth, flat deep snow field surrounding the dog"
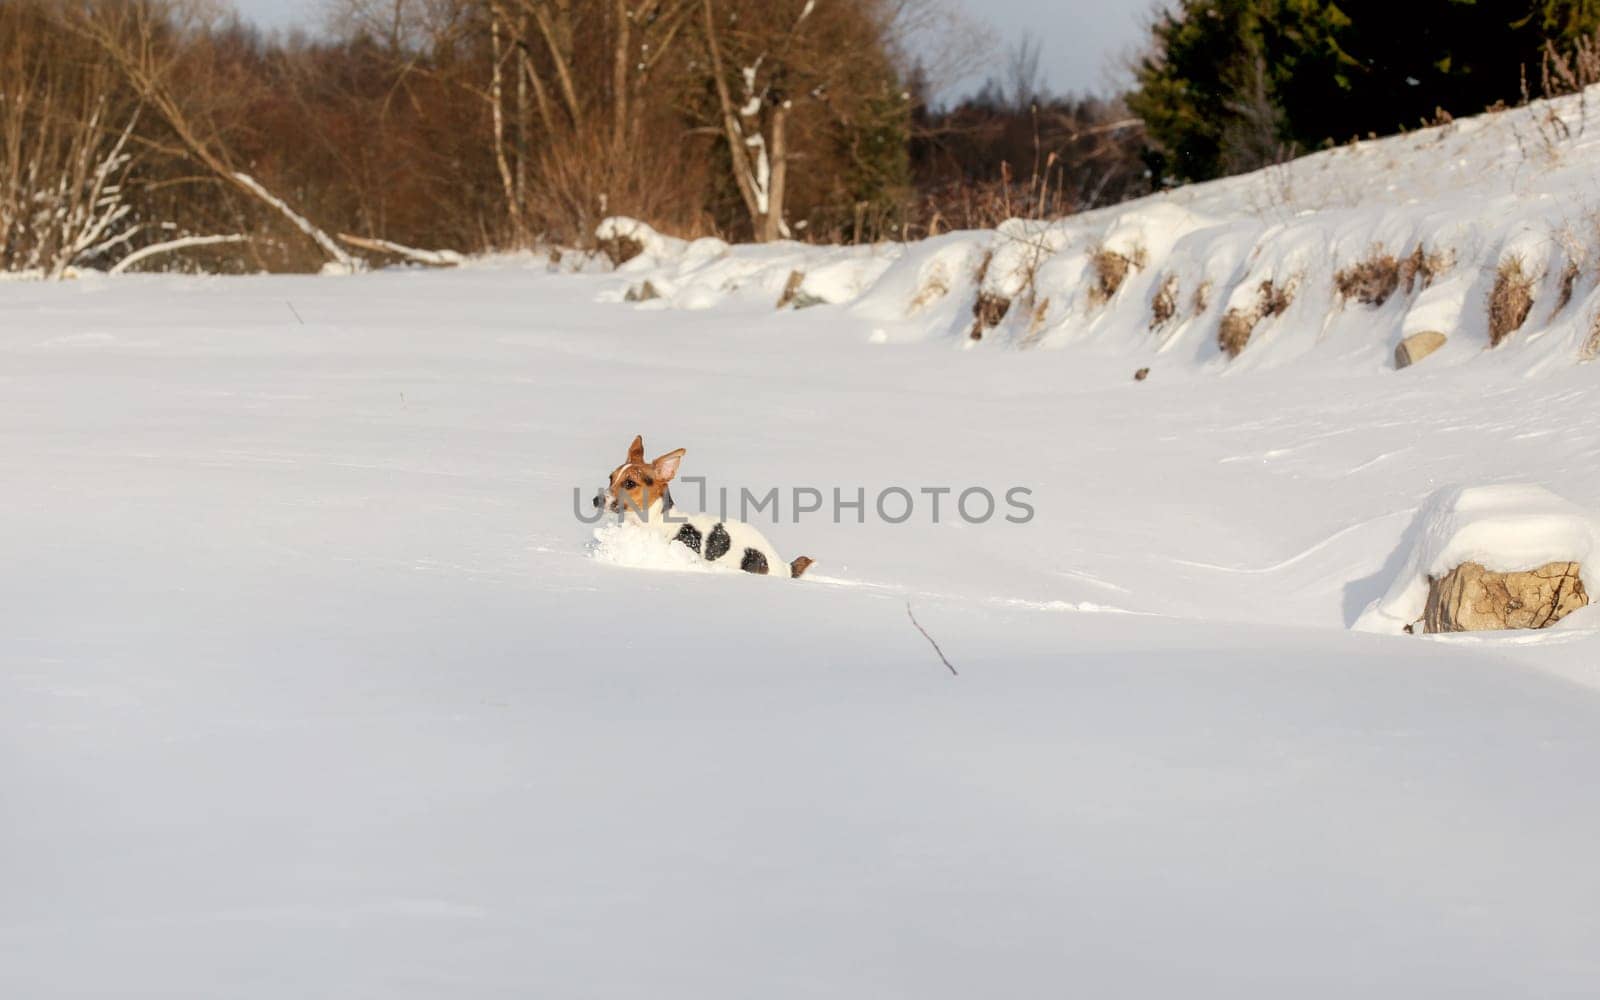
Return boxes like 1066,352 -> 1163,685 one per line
9,91 -> 1600,1000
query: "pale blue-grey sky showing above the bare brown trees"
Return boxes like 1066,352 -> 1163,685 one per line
228,0 -> 1152,93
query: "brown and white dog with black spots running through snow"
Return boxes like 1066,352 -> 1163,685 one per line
595,437 -> 811,576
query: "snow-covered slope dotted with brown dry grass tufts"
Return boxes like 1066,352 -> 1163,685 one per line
606,84 -> 1600,376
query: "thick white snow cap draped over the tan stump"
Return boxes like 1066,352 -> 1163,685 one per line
1354,485 -> 1600,634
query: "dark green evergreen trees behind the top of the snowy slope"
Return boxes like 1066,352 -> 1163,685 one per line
1128,0 -> 1600,179
